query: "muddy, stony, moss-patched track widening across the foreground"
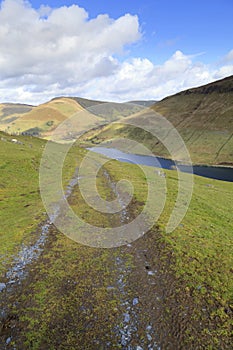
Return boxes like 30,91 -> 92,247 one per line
0,163 -> 231,350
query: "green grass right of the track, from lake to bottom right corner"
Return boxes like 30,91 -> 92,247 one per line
101,161 -> 233,349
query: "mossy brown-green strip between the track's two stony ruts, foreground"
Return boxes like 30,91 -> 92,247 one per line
18,234 -> 125,349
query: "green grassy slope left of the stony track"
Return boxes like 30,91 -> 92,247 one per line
0,133 -> 83,275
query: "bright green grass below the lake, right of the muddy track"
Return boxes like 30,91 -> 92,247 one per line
104,161 -> 233,304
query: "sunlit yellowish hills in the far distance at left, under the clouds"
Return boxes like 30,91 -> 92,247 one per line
0,96 -> 146,141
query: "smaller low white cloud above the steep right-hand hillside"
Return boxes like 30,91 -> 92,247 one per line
81,51 -> 233,101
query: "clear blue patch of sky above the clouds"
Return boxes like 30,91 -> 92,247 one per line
31,0 -> 233,63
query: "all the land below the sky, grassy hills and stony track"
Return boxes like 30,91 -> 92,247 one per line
0,77 -> 233,350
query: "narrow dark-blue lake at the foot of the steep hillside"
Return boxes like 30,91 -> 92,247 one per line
88,147 -> 233,182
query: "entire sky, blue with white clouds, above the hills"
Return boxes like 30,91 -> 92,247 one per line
0,0 -> 233,103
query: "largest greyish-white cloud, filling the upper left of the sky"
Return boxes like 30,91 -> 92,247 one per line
0,0 -> 138,97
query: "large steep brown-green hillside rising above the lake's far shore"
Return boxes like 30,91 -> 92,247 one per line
82,76 -> 233,165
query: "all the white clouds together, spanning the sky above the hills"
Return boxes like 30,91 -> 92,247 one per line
0,0 -> 233,104
